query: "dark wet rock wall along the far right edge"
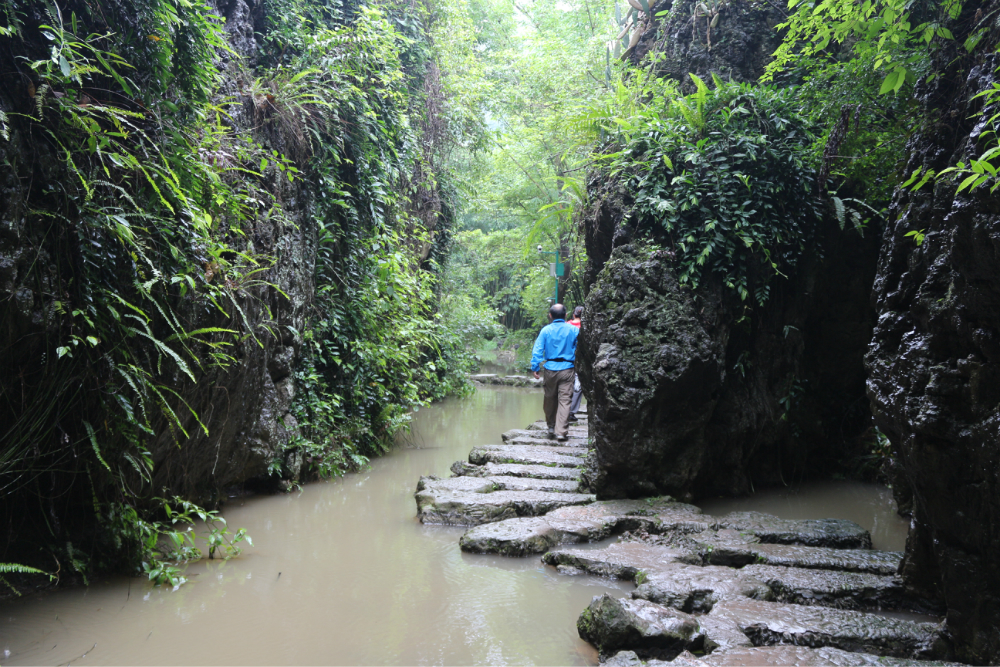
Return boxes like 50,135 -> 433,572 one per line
866,3 -> 1000,664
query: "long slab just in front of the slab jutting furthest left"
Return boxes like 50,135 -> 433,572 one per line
459,500 -> 700,556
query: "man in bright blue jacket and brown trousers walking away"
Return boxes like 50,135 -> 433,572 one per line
531,303 -> 580,441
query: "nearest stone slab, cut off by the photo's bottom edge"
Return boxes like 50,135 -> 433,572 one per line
664,646 -> 961,667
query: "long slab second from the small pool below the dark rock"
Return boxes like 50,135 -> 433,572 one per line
692,530 -> 903,575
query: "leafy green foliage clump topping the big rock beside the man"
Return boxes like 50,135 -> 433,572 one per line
605,79 -> 822,304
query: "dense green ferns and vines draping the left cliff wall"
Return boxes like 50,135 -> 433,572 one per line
0,0 -> 474,585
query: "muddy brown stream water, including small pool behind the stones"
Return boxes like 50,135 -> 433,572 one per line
0,388 -> 906,665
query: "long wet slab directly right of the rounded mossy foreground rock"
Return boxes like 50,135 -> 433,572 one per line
709,598 -> 949,659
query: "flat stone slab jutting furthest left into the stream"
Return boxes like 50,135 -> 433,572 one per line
416,486 -> 594,526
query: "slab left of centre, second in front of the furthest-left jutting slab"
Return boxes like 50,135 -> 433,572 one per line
542,542 -> 701,581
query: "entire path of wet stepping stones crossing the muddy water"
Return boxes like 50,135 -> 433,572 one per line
416,415 -> 953,667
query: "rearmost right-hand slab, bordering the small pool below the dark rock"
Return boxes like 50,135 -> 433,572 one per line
713,512 -> 872,549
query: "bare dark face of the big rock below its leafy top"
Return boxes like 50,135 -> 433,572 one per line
577,235 -> 876,499
